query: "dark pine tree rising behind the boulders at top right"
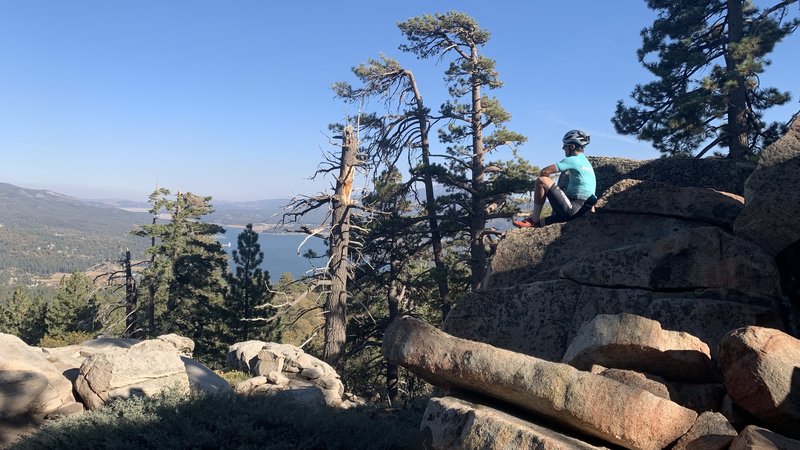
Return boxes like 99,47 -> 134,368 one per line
612,0 -> 798,159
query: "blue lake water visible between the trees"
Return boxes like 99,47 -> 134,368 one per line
218,228 -> 325,283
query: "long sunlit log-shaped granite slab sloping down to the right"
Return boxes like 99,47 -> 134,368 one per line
383,317 -> 697,449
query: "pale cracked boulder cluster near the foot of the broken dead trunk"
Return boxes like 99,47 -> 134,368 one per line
226,341 -> 351,407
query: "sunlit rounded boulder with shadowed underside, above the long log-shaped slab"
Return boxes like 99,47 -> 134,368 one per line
562,314 -> 714,381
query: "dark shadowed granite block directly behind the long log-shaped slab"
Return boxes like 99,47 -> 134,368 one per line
443,280 -> 784,361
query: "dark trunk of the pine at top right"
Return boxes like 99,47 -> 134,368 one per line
725,0 -> 749,159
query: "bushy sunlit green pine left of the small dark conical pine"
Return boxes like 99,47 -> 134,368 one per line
136,189 -> 230,365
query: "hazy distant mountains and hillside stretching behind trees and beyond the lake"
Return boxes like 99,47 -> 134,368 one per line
0,182 -> 327,283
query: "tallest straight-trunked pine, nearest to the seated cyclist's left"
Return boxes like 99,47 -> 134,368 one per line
398,11 -> 531,290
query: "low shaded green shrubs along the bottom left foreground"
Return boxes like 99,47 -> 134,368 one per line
13,393 -> 422,450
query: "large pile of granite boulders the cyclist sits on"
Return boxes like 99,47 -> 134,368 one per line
383,120 -> 800,449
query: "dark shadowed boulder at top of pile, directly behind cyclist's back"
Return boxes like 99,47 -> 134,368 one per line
587,155 -> 756,196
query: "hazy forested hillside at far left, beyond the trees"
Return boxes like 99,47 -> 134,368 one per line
0,183 -> 150,281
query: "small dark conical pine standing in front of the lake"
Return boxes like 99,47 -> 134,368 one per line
226,224 -> 279,342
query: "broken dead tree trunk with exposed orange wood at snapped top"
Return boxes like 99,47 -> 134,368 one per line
323,125 -> 358,373
